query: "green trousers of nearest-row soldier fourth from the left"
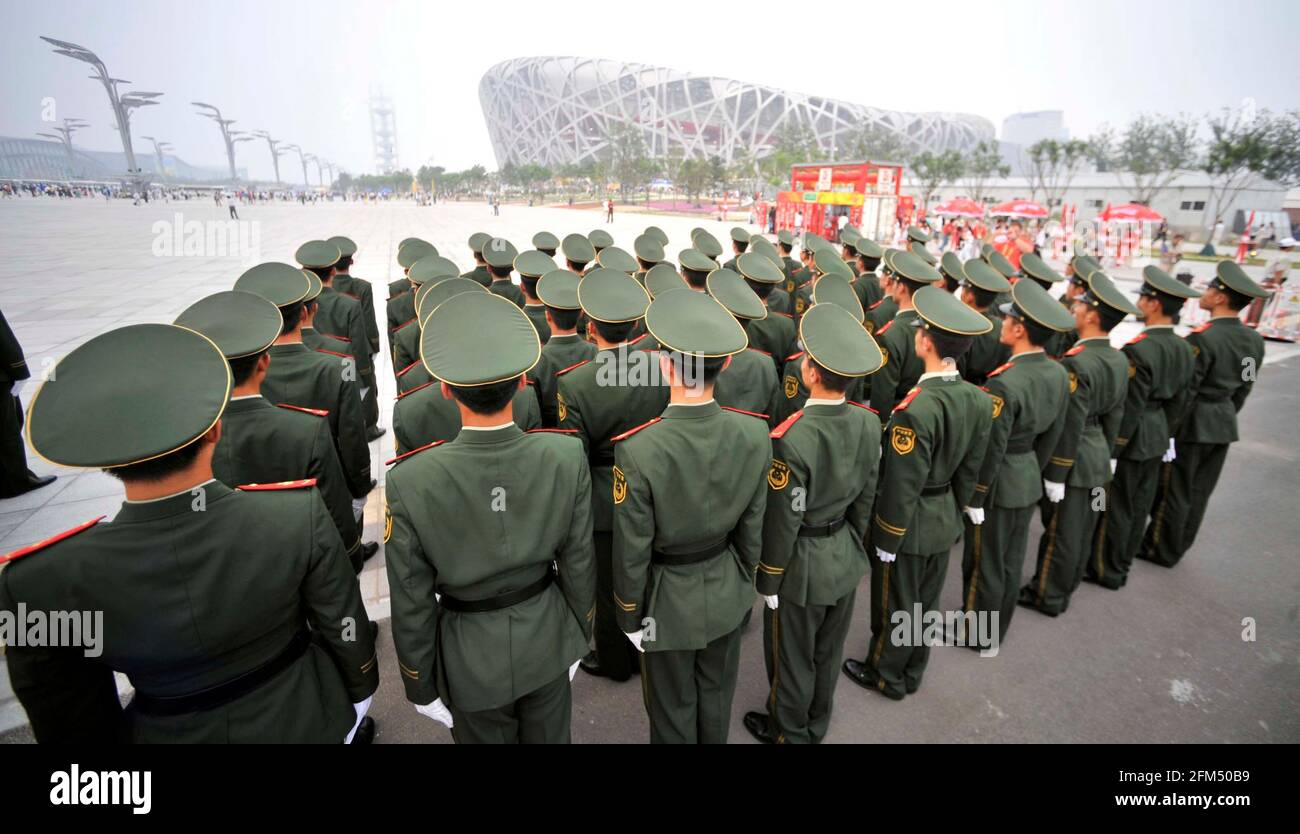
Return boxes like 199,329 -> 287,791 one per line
763,590 -> 857,744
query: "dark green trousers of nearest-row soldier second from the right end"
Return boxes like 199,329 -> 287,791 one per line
1088,457 -> 1161,588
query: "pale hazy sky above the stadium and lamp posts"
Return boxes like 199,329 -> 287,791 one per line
0,0 -> 1300,178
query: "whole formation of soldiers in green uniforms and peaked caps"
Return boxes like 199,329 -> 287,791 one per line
0,219 -> 1265,743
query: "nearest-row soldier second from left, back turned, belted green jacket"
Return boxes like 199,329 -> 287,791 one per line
385,292 -> 595,743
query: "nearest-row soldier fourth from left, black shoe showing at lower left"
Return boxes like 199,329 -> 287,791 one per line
744,304 -> 883,744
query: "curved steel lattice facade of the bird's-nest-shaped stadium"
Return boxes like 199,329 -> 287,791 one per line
478,57 -> 995,166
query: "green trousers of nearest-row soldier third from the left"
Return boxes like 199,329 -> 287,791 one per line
641,625 -> 740,744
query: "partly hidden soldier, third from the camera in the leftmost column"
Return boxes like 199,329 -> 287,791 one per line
234,262 -> 376,501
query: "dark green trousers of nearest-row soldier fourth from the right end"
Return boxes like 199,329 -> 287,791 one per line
962,504 -> 1034,643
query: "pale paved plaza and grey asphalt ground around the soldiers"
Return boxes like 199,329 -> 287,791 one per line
0,199 -> 1300,742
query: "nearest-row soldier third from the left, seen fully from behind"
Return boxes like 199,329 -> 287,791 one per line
612,292 -> 772,743
